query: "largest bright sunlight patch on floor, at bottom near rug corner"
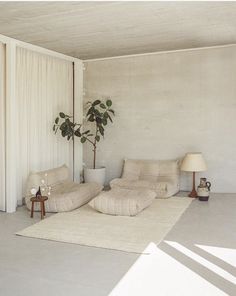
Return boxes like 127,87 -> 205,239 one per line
109,243 -> 227,296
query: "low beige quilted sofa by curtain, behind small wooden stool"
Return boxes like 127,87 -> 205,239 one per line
25,165 -> 103,212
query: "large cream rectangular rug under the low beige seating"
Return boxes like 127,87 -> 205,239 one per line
16,197 -> 192,253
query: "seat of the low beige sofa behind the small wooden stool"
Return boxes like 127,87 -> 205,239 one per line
25,181 -> 103,213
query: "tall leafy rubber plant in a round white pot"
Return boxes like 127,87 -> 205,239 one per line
53,99 -> 115,185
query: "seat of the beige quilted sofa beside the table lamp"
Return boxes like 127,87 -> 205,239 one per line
110,178 -> 178,198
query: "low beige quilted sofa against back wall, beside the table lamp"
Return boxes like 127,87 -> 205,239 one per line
110,159 -> 179,198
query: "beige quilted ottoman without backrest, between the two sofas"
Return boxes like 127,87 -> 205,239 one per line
89,188 -> 156,216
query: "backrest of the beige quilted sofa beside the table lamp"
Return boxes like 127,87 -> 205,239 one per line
122,159 -> 179,181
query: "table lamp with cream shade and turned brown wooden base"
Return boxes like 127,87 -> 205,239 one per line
181,152 -> 207,197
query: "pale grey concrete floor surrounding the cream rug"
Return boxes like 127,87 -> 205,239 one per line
0,194 -> 236,296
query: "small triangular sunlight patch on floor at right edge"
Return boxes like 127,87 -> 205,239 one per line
195,245 -> 236,267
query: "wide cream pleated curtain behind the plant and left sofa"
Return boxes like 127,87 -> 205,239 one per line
16,48 -> 73,203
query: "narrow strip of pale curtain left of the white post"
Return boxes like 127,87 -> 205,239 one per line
0,42 -> 6,211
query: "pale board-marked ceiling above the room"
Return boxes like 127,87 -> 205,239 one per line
0,1 -> 236,59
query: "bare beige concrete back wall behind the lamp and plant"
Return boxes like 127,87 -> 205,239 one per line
84,46 -> 236,192
